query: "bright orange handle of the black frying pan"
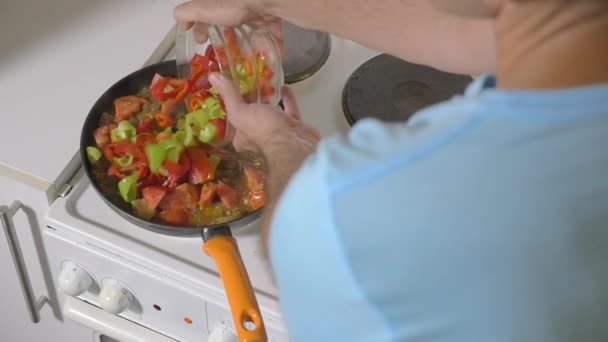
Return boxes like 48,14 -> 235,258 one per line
203,227 -> 268,342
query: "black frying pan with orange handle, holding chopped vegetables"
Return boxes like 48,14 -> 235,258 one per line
80,60 -> 267,342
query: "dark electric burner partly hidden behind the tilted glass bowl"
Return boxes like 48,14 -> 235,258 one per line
283,21 -> 331,84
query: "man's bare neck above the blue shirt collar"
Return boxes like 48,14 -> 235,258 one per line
496,0 -> 608,89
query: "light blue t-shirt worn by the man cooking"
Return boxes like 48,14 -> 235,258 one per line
270,77 -> 608,342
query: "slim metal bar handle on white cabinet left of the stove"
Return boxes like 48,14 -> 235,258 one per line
0,201 -> 49,323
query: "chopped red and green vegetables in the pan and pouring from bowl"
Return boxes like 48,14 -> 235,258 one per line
86,44 -> 274,226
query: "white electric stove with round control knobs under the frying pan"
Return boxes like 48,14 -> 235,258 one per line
44,30 -> 378,342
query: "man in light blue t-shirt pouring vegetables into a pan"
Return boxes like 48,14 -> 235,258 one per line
175,0 -> 608,342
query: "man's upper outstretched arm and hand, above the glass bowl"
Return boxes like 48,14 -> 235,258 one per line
175,0 -> 496,75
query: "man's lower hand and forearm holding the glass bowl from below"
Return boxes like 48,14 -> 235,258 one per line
209,73 -> 320,251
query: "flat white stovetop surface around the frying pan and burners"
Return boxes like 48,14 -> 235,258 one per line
47,36 -> 378,307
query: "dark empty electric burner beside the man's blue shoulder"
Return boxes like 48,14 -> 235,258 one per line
342,54 -> 473,125
